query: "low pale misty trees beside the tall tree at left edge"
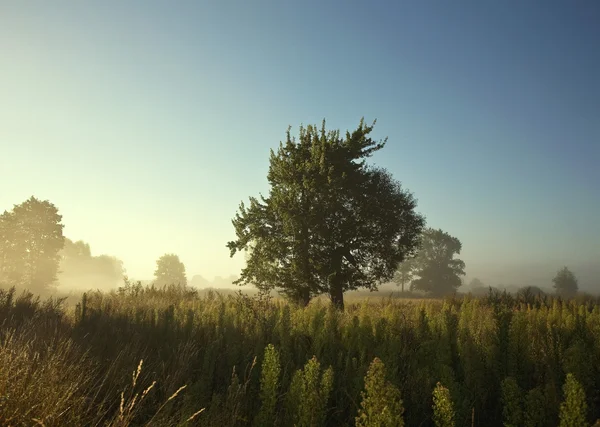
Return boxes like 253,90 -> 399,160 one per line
58,239 -> 125,288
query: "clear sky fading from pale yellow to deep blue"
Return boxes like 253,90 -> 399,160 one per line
0,0 -> 600,286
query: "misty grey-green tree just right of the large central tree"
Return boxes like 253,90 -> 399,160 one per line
411,228 -> 465,295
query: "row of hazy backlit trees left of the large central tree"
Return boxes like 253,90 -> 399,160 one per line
0,196 -> 187,293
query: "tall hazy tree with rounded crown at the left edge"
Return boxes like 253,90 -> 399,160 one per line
0,196 -> 64,292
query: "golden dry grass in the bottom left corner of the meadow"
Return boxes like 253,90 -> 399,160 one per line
0,289 -> 204,427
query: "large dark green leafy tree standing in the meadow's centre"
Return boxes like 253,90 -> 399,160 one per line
227,120 -> 424,308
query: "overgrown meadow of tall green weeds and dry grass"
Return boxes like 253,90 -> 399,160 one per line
0,286 -> 600,426
